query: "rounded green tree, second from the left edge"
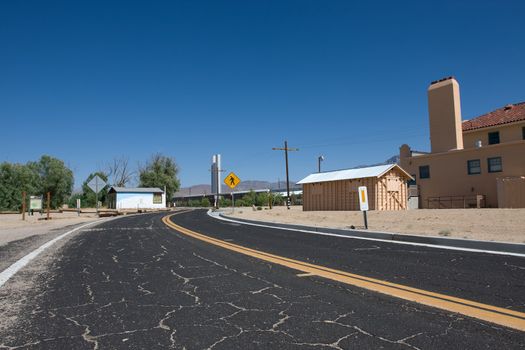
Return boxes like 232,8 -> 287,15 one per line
28,155 -> 73,208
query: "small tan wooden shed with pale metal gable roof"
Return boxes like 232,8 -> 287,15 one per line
298,164 -> 412,211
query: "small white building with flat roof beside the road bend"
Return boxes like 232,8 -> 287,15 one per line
108,186 -> 166,210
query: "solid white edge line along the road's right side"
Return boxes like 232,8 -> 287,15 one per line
207,210 -> 525,258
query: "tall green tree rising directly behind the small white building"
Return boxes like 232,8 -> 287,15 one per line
139,153 -> 180,202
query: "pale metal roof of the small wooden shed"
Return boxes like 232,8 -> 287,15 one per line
298,164 -> 412,185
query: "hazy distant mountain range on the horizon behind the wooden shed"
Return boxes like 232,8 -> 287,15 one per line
175,155 -> 399,197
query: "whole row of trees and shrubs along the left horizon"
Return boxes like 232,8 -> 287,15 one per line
0,153 -> 180,211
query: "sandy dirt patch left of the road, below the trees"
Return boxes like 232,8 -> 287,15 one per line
0,212 -> 98,246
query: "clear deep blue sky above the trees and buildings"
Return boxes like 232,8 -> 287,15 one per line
0,0 -> 525,187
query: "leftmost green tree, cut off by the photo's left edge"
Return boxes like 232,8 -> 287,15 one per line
0,162 -> 42,210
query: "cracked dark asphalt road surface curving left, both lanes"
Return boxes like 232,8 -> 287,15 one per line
0,211 -> 525,349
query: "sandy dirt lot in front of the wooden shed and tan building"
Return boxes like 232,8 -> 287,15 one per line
225,206 -> 525,243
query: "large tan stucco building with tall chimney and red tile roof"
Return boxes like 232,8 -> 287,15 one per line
400,77 -> 525,208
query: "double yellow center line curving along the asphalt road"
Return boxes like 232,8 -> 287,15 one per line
162,214 -> 525,331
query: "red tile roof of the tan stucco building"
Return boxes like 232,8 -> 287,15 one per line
462,102 -> 525,131
